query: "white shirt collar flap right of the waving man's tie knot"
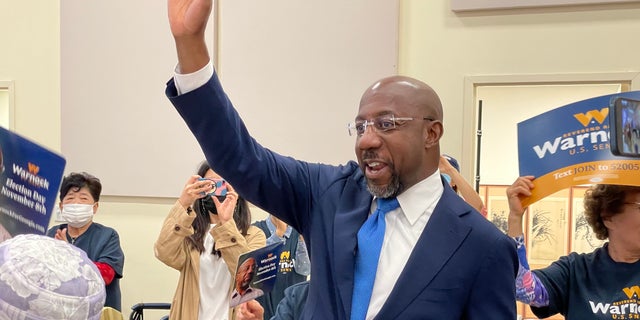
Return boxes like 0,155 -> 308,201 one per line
397,170 -> 444,225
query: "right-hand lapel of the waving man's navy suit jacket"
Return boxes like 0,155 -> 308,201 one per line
376,188 -> 471,319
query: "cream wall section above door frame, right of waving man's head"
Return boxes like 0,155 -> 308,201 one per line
399,0 -> 640,181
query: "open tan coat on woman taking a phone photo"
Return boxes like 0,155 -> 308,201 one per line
154,201 -> 266,320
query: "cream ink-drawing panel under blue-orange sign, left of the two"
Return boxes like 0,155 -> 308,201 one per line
527,189 -> 570,265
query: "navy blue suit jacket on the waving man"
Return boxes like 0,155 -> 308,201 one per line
166,75 -> 518,320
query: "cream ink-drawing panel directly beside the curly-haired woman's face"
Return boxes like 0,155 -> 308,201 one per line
571,187 -> 605,253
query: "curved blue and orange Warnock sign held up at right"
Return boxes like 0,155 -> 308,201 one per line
518,91 -> 640,205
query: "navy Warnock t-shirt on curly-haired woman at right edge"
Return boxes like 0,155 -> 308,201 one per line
531,243 -> 640,320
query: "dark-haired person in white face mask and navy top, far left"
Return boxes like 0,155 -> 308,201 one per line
47,172 -> 124,311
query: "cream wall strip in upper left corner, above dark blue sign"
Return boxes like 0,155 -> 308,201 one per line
0,0 -> 60,151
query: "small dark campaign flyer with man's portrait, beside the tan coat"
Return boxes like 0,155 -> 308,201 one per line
229,242 -> 284,307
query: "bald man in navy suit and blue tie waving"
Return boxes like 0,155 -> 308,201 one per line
166,0 -> 518,320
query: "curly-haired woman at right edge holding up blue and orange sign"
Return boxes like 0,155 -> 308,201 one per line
507,176 -> 640,320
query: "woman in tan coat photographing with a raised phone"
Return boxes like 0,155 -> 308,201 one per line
154,162 -> 266,320
